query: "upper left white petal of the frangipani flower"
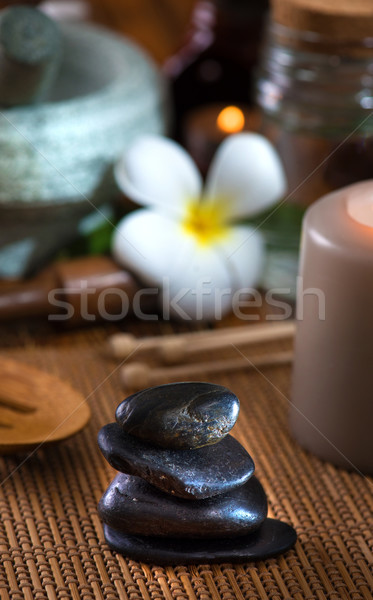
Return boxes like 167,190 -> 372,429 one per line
114,135 -> 202,213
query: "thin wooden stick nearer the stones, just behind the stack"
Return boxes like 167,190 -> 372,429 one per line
120,352 -> 293,390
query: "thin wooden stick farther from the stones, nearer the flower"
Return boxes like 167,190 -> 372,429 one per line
108,321 -> 295,362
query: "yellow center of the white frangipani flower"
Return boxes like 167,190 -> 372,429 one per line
182,199 -> 229,246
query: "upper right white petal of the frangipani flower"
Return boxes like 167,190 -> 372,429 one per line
205,133 -> 286,219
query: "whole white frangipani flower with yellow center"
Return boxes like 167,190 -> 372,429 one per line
113,133 -> 285,319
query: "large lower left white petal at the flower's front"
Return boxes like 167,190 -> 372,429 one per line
113,209 -> 235,320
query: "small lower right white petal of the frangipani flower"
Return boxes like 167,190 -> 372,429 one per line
212,225 -> 264,290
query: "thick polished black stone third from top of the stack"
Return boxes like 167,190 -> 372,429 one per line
98,473 -> 267,538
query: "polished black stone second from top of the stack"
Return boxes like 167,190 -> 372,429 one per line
98,423 -> 254,499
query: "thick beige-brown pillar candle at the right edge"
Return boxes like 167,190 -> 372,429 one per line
290,180 -> 373,472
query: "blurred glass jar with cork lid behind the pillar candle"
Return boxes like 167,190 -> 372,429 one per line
257,0 -> 373,294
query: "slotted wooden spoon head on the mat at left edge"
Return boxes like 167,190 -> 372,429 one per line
0,357 -> 91,454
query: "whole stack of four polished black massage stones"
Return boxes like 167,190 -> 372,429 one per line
98,382 -> 296,564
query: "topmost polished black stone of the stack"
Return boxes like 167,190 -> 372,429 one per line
115,382 -> 240,449
